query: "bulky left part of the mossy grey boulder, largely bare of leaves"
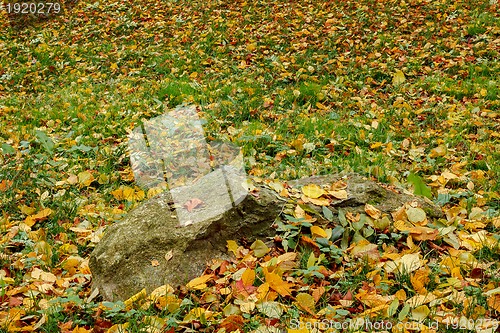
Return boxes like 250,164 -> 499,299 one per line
90,169 -> 283,300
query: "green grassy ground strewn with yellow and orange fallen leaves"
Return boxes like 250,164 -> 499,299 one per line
0,0 -> 500,332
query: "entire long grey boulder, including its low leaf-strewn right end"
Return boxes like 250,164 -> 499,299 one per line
90,173 -> 442,300
